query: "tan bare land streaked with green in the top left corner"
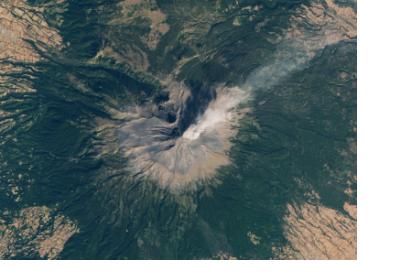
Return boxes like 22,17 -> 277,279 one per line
0,0 -> 62,95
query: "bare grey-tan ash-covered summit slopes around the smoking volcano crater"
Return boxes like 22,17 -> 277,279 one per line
96,82 -> 249,188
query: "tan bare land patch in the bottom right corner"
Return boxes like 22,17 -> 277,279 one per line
282,203 -> 357,260
